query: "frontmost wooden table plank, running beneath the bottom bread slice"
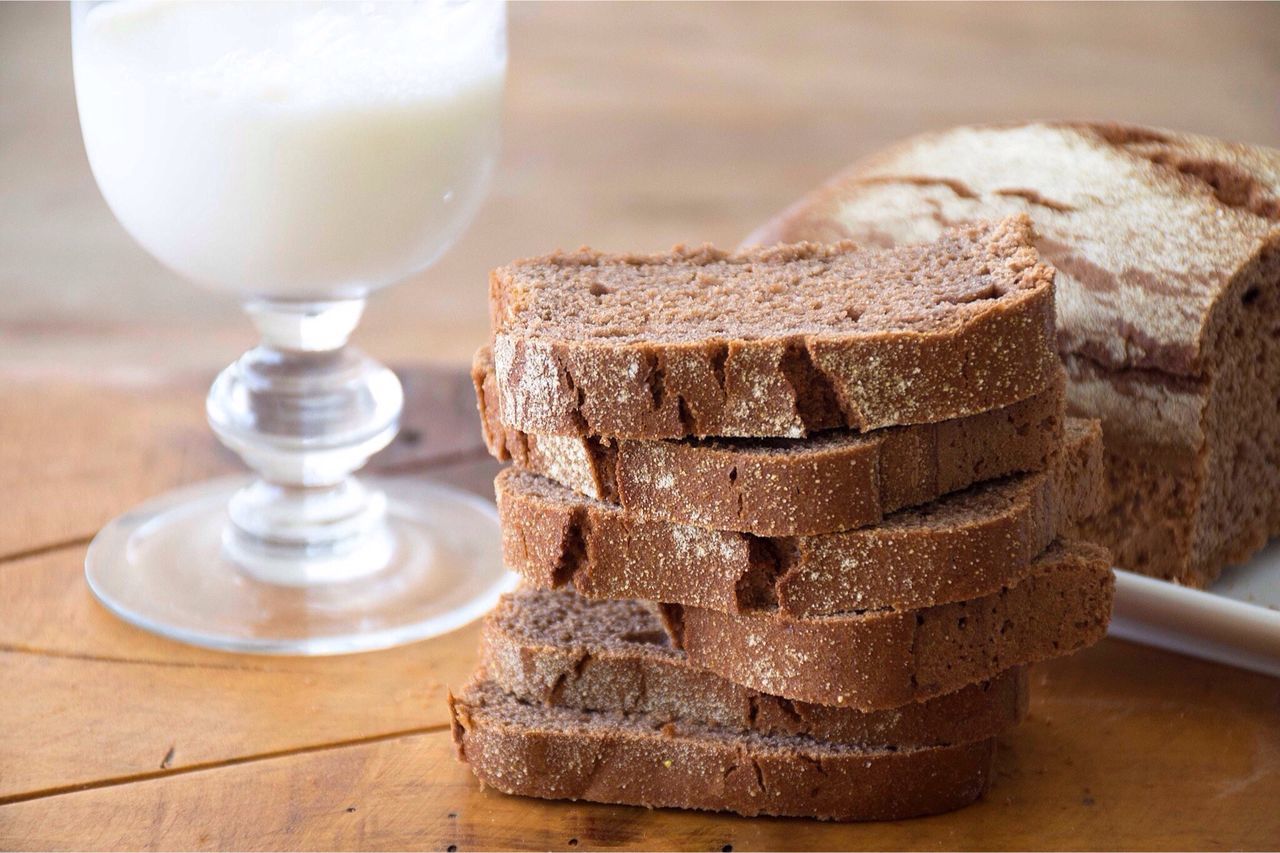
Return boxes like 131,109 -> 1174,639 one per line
0,640 -> 1280,850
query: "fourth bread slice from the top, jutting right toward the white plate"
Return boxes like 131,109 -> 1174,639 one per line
663,540 -> 1115,710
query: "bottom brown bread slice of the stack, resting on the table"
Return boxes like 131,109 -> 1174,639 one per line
449,674 -> 996,821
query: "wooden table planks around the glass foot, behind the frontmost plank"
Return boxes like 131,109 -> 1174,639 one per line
0,368 -> 498,802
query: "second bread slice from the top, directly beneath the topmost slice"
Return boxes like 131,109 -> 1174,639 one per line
472,347 -> 1065,537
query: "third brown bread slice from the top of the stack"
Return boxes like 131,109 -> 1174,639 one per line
494,420 -> 1103,616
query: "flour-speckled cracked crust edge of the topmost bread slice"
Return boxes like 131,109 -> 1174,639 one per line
490,215 -> 1057,439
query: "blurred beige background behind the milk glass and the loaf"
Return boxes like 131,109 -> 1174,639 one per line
0,3 -> 1280,382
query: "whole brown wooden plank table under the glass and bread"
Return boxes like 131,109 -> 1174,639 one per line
0,369 -> 1280,850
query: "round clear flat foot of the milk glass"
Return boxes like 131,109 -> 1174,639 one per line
84,476 -> 516,654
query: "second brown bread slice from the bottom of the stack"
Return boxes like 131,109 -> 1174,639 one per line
483,588 -> 1028,748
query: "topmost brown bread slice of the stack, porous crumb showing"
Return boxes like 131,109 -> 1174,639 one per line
490,215 -> 1057,438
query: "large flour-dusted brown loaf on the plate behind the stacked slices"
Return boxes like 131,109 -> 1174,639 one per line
748,123 -> 1280,585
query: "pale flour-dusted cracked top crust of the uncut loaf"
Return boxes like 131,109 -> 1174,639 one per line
744,122 -> 1280,377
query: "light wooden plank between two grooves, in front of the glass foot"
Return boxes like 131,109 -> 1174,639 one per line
0,479 -> 492,802
